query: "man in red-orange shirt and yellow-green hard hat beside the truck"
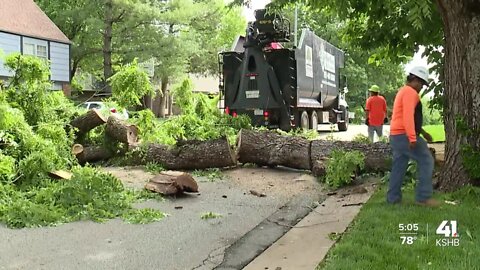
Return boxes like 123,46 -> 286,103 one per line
365,85 -> 387,142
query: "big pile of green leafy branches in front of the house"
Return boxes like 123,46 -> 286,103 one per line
0,55 -> 167,228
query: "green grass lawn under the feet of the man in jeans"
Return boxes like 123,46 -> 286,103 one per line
317,185 -> 480,270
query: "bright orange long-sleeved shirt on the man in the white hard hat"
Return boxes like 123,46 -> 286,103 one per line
390,85 -> 423,142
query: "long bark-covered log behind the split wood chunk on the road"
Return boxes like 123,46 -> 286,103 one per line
131,138 -> 236,170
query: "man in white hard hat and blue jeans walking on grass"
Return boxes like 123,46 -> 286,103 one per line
387,66 -> 439,206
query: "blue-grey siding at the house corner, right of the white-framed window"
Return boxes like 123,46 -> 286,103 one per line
50,42 -> 70,82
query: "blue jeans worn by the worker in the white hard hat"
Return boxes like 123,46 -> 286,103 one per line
387,134 -> 434,203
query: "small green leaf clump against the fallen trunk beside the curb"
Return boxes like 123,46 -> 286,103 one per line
323,150 -> 365,188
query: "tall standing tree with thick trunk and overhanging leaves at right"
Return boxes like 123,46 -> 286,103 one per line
268,0 -> 480,190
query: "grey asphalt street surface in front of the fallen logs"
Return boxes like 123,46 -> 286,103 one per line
0,169 -> 317,270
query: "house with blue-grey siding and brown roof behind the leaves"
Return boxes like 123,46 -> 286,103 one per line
0,0 -> 71,95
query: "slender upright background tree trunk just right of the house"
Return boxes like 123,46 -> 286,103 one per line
103,0 -> 113,93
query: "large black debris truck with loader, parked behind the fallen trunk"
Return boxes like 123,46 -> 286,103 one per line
220,10 -> 348,131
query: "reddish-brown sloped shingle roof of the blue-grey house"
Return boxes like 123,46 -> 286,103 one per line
0,0 -> 71,43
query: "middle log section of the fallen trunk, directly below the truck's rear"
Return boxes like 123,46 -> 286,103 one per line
237,129 -> 311,170
